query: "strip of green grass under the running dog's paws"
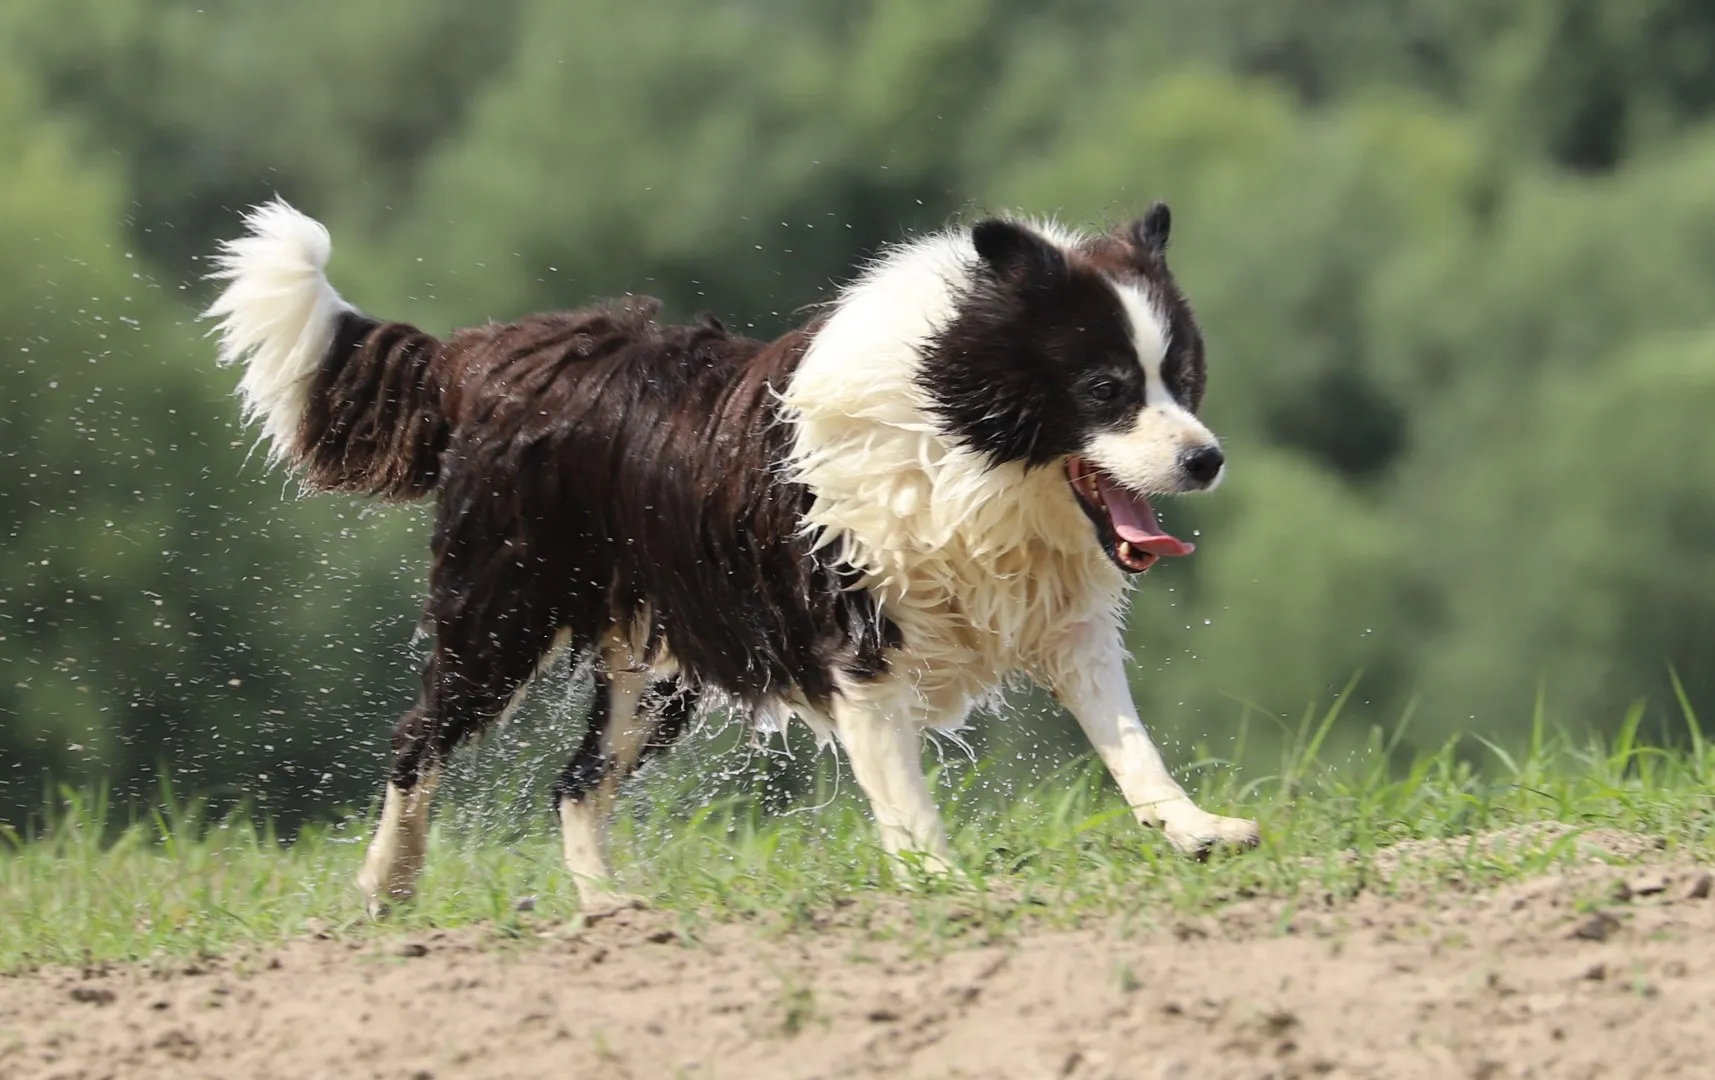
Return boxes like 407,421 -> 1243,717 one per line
0,708 -> 1715,970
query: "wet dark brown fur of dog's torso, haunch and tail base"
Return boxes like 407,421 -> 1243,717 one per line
295,298 -> 897,785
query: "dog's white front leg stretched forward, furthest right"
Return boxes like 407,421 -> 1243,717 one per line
1050,627 -> 1257,854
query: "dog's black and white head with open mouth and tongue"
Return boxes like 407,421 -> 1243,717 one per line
921,202 -> 1226,573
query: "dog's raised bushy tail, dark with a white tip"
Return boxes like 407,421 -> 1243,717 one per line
206,199 -> 448,499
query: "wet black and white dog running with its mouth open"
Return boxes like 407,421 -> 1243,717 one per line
209,202 -> 1257,912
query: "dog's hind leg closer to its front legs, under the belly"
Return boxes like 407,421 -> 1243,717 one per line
554,665 -> 695,914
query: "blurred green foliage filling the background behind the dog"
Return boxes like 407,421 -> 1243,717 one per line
0,0 -> 1715,821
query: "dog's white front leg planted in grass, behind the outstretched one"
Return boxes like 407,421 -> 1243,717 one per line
833,698 -> 952,873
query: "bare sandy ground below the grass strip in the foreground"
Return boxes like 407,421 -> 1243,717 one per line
0,838 -> 1715,1080
